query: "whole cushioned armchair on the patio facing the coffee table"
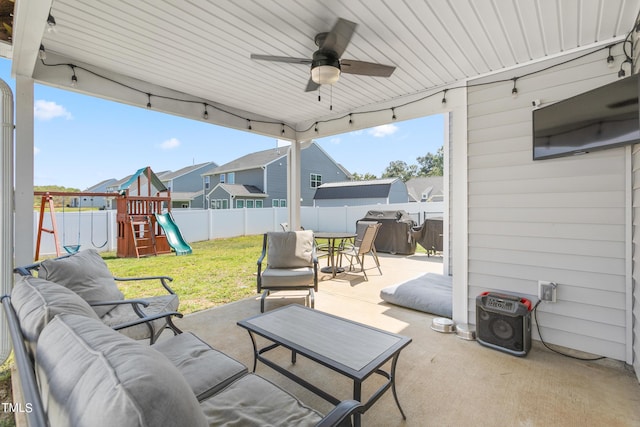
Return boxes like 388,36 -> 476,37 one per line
257,230 -> 318,312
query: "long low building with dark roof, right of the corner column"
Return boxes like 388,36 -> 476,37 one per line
313,178 -> 409,207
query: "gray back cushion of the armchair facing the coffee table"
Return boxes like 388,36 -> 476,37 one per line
267,230 -> 313,268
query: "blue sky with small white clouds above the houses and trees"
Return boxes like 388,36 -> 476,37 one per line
0,59 -> 444,190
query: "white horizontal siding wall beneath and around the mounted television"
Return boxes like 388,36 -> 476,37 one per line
464,50 -> 628,360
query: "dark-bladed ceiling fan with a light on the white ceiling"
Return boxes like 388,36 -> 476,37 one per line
251,18 -> 396,92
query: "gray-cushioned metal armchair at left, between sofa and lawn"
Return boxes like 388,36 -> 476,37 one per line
15,249 -> 182,344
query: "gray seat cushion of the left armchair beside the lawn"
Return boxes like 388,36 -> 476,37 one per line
101,294 -> 180,340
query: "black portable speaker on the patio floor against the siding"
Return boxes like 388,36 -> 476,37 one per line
476,292 -> 531,356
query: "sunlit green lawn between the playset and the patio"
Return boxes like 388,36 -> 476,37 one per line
102,235 -> 262,314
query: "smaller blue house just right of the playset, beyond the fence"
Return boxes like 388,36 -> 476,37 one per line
159,162 -> 218,208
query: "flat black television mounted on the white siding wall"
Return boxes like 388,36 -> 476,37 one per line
533,75 -> 640,160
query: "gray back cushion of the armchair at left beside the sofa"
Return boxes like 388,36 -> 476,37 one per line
38,249 -> 124,317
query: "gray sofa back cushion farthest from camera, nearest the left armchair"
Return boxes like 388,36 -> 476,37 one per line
11,276 -> 99,357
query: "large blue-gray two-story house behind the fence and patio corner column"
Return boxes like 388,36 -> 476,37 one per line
204,142 -> 351,209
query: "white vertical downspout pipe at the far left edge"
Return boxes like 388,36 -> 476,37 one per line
0,80 -> 13,363
